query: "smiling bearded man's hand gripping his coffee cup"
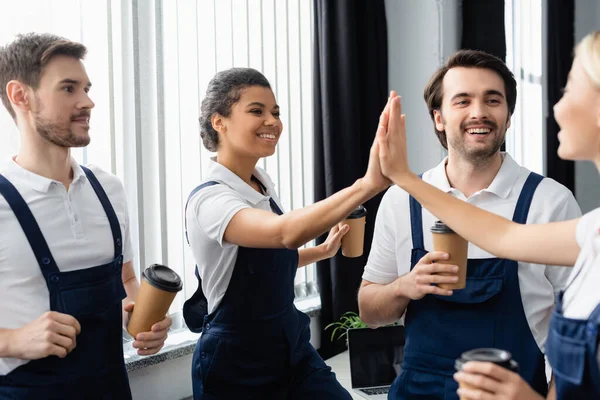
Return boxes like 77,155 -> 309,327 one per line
393,251 -> 458,300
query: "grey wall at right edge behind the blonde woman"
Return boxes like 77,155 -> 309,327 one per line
575,0 -> 600,212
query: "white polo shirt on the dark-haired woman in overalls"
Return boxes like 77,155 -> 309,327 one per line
185,158 -> 283,313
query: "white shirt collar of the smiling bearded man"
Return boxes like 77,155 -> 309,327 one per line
431,152 -> 520,199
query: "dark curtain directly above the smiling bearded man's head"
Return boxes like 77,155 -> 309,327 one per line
461,0 -> 510,61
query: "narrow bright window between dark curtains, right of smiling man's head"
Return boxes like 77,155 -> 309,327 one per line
505,0 -> 546,174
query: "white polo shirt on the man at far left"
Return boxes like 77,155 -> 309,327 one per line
0,159 -> 132,375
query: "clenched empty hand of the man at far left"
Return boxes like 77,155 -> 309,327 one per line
8,311 -> 81,360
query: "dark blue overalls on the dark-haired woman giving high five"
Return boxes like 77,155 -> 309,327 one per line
184,181 -> 351,400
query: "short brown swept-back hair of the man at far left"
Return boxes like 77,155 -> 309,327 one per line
0,33 -> 87,119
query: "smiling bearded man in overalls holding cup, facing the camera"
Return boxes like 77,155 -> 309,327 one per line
359,50 -> 580,400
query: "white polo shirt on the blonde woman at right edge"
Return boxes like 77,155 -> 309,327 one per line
563,208 -> 600,366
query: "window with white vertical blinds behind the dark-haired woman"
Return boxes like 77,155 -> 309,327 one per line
159,0 -> 316,310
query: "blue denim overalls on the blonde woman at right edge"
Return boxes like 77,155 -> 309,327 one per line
546,265 -> 600,400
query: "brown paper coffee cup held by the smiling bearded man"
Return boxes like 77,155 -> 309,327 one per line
430,221 -> 469,290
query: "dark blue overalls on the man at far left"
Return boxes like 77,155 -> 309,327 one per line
0,166 -> 131,400
